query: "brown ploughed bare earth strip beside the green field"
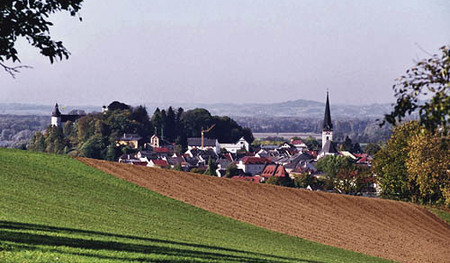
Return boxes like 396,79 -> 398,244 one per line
79,158 -> 450,262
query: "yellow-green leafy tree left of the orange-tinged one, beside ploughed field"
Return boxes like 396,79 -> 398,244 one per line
373,121 -> 419,200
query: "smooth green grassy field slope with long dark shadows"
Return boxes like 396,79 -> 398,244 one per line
0,149 -> 388,263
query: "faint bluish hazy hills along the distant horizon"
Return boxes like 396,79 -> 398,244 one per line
0,100 -> 391,119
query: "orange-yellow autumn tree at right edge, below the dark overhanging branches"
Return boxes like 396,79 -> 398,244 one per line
406,131 -> 450,206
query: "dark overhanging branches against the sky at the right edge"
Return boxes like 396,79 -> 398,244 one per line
382,46 -> 450,136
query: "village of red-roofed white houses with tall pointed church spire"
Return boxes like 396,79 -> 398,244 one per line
78,94 -> 379,196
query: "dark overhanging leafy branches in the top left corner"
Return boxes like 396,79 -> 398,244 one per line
0,0 -> 83,77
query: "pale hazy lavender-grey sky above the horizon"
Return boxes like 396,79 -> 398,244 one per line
0,0 -> 450,105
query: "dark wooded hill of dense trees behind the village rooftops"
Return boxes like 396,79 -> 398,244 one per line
28,101 -> 253,160
